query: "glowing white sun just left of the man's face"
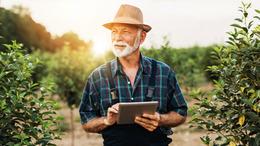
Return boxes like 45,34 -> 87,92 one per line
93,34 -> 111,56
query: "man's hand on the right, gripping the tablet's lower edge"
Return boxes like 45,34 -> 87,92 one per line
135,112 -> 160,132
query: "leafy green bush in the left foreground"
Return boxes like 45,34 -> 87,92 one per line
0,42 -> 61,145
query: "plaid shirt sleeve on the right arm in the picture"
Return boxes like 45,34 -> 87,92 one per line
167,70 -> 188,116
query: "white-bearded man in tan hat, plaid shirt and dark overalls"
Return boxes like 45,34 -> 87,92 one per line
79,5 -> 187,146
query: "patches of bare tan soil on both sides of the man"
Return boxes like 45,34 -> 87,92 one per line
54,83 -> 216,146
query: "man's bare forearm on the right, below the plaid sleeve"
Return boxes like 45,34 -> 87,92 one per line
159,111 -> 186,127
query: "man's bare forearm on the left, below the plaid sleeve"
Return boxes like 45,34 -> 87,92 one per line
82,117 -> 108,133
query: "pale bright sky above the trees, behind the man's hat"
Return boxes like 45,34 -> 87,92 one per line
0,0 -> 260,51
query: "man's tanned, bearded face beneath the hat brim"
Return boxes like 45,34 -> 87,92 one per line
111,24 -> 141,57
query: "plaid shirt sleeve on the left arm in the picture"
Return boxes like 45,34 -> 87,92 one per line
79,76 -> 99,124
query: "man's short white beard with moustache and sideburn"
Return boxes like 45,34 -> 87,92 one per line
112,32 -> 141,57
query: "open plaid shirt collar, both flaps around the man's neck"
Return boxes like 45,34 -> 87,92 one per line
111,53 -> 151,77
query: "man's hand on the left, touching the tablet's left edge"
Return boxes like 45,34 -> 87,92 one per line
104,103 -> 119,126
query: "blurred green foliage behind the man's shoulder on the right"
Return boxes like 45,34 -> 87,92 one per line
142,38 -> 216,91
